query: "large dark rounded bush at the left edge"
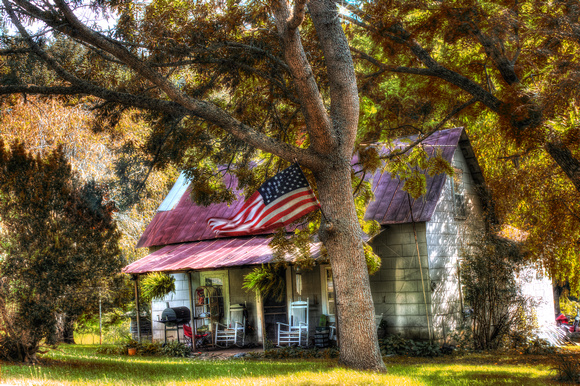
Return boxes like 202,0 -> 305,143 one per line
0,140 -> 123,362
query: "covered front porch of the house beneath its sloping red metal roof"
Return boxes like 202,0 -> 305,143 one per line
123,236 -> 335,350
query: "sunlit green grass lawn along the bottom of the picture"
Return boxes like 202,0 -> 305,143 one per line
0,345 -> 554,386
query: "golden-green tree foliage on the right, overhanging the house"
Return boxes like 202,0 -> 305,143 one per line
345,0 -> 580,291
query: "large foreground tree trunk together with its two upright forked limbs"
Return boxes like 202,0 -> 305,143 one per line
273,0 -> 386,371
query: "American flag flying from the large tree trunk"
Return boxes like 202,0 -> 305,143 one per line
207,164 -> 320,236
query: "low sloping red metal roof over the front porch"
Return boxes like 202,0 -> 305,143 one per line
123,236 -> 321,274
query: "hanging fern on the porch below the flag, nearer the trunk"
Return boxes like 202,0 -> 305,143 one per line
243,263 -> 286,301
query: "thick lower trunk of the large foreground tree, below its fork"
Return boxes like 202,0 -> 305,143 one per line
316,164 -> 386,371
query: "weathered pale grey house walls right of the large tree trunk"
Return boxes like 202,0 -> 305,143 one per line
370,148 -> 483,340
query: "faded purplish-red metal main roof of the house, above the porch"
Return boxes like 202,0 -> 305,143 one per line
137,128 -> 483,248
